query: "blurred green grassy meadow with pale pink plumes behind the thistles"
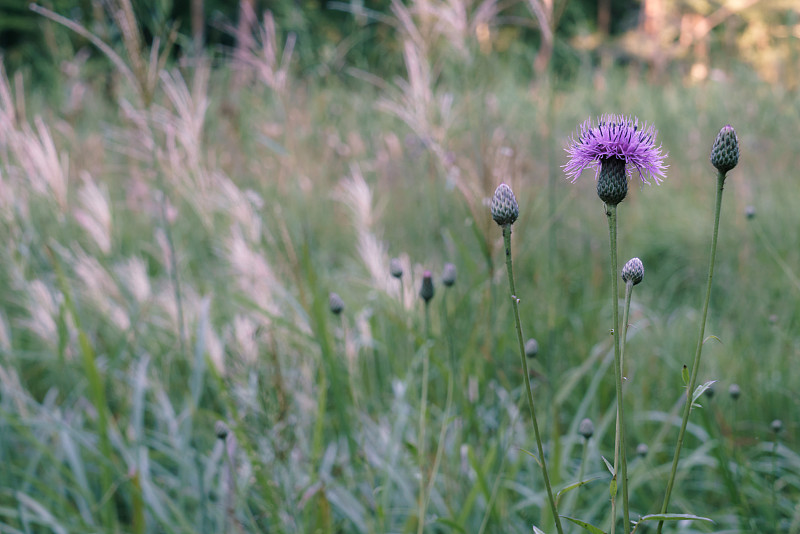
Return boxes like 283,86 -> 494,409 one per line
0,5 -> 800,534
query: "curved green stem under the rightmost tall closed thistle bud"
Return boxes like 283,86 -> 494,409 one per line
657,171 -> 725,534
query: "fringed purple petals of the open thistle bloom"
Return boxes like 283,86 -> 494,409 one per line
564,115 -> 666,184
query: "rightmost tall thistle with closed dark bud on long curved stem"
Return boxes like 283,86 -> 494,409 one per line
656,124 -> 739,534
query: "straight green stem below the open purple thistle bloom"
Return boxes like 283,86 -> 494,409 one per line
606,205 -> 631,534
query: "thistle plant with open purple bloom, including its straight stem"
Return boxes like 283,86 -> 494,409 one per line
564,115 -> 666,534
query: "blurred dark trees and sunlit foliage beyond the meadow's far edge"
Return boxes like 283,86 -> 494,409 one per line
0,0 -> 800,91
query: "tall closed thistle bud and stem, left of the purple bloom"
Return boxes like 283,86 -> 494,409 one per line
491,184 -> 564,534
